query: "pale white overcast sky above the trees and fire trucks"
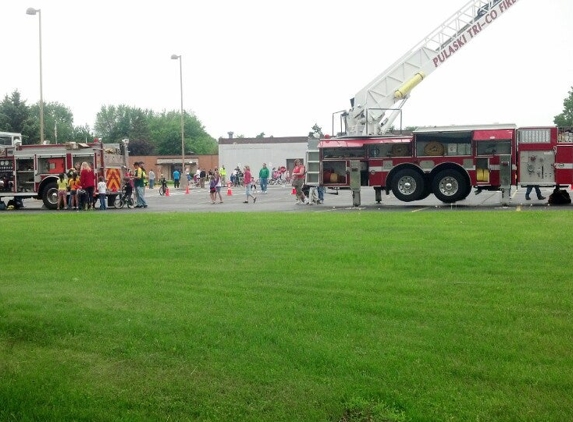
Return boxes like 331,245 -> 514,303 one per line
0,0 -> 573,138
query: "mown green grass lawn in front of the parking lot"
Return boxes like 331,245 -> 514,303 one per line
0,211 -> 573,422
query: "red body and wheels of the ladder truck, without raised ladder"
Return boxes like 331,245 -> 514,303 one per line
309,125 -> 573,206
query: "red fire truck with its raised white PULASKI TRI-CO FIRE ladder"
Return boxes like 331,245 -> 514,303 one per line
306,0 -> 573,206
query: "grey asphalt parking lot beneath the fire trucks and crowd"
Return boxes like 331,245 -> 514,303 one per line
13,186 -> 571,213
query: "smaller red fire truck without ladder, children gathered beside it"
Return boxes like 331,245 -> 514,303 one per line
0,132 -> 128,209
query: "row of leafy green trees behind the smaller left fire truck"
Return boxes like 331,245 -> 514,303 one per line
0,90 -> 218,155
